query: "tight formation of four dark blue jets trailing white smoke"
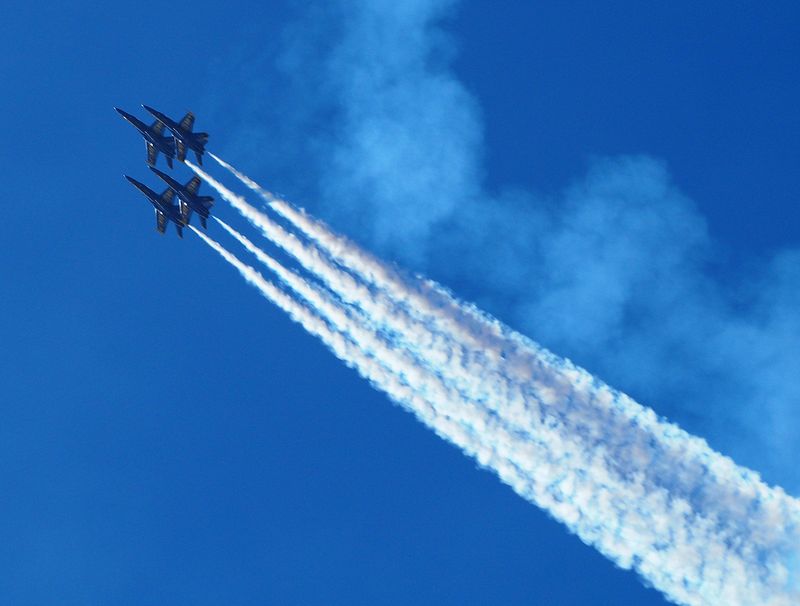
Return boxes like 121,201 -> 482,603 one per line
114,105 -> 214,238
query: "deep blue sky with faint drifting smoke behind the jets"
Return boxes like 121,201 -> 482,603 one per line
0,0 -> 800,605
